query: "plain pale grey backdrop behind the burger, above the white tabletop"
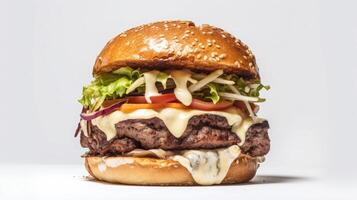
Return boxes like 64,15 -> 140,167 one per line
0,0 -> 357,199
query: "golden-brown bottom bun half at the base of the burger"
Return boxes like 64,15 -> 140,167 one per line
85,155 -> 258,185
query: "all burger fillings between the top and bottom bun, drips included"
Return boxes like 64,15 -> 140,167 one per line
76,67 -> 270,184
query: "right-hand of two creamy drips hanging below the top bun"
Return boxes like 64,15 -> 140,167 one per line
170,70 -> 192,106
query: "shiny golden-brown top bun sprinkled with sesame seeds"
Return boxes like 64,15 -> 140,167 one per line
93,21 -> 259,79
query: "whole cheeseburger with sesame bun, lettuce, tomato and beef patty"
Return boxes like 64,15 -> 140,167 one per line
75,21 -> 270,185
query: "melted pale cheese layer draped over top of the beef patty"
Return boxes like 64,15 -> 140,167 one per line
92,107 -> 242,140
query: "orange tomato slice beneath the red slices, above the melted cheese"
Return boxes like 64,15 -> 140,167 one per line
119,103 -> 187,113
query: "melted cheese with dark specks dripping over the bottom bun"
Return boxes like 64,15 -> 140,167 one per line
172,145 -> 240,185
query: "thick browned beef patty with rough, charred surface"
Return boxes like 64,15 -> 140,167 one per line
80,114 -> 270,156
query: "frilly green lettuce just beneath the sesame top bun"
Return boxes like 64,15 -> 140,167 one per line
79,67 -> 270,111
